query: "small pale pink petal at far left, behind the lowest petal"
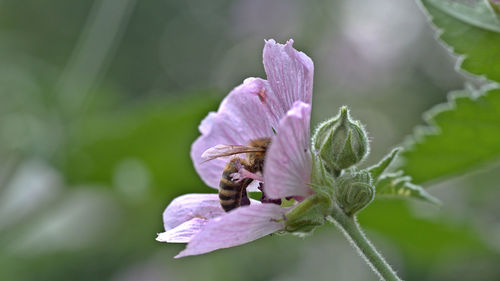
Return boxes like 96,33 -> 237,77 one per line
163,194 -> 225,231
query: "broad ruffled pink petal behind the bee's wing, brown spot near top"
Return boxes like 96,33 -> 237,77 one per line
191,78 -> 280,188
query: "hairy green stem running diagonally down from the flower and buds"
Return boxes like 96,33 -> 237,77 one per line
332,207 -> 401,281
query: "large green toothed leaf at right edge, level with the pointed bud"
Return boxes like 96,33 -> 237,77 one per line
401,86 -> 500,184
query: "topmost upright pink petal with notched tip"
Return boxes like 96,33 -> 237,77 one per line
264,39 -> 314,108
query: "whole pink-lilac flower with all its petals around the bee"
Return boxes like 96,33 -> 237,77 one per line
157,40 -> 314,258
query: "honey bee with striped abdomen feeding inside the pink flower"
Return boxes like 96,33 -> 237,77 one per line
202,138 -> 271,212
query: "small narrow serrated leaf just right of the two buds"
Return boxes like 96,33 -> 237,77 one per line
375,171 -> 441,205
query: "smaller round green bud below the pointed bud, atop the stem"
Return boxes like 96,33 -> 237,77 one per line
335,171 -> 375,216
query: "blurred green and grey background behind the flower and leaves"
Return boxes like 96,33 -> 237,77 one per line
0,0 -> 500,281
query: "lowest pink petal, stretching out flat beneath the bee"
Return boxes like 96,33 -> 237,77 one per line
176,204 -> 288,258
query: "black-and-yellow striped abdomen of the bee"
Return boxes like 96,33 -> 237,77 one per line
219,157 -> 252,212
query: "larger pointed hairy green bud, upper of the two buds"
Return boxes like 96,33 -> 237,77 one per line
313,106 -> 369,172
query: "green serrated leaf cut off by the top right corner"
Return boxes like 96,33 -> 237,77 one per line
421,0 -> 500,81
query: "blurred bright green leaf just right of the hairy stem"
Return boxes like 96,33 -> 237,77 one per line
358,200 -> 498,264
